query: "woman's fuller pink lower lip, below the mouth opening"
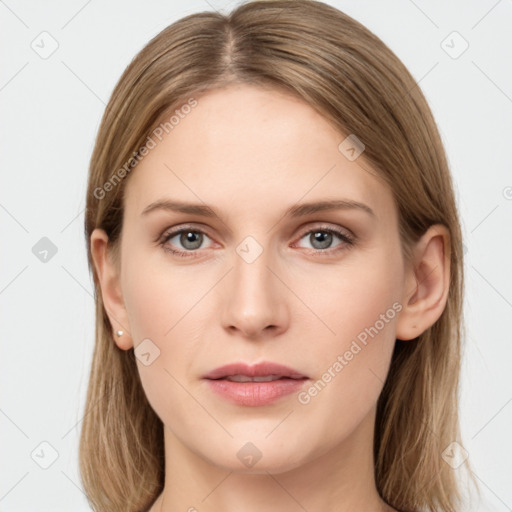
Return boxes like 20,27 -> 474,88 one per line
206,379 -> 308,407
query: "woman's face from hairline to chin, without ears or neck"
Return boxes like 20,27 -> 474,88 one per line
105,85 -> 410,472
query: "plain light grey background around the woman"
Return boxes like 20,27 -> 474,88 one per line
0,0 -> 512,512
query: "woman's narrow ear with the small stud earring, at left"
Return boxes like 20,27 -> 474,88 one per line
91,229 -> 133,350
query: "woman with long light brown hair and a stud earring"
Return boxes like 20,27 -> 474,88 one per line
80,0 -> 476,512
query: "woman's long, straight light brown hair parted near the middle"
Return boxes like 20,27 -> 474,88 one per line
80,0 -> 476,512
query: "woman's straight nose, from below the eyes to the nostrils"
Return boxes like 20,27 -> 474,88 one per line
221,245 -> 289,339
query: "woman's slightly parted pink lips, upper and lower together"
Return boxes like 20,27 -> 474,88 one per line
203,362 -> 308,407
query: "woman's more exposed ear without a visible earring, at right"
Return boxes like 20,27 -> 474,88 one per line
396,224 -> 450,340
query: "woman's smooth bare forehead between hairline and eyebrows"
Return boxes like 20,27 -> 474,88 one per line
125,84 -> 393,221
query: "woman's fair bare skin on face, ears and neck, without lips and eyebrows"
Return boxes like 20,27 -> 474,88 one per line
91,85 -> 449,512
